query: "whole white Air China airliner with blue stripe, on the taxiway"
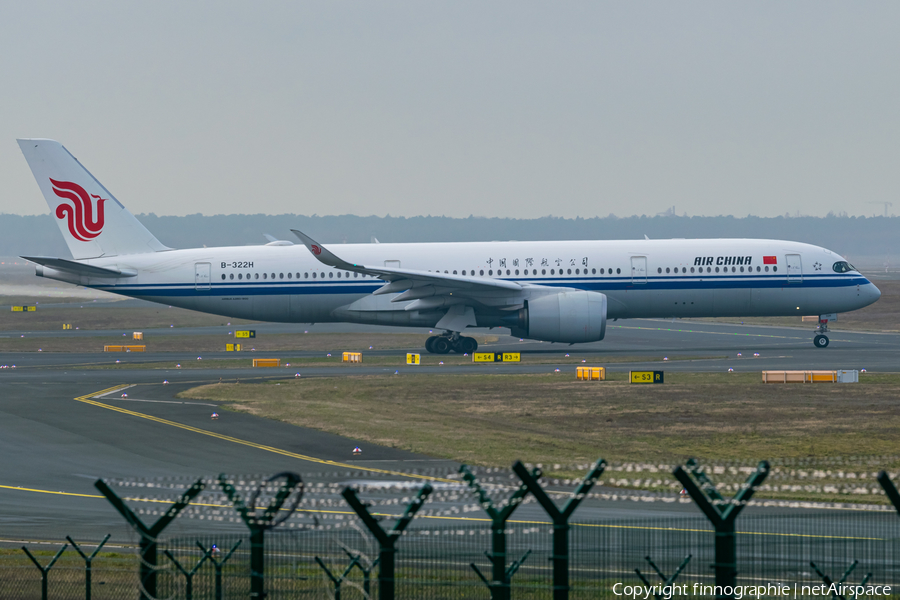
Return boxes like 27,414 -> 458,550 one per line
18,139 -> 881,354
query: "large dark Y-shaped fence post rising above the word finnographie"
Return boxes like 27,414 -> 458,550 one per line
672,459 -> 769,598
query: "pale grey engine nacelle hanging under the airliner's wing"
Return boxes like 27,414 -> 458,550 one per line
524,290 -> 606,344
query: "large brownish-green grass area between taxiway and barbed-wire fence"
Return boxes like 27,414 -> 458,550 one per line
181,370 -> 900,466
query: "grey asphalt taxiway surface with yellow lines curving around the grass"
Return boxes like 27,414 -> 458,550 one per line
0,320 -> 900,542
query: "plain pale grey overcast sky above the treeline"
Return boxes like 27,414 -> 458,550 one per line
0,0 -> 900,217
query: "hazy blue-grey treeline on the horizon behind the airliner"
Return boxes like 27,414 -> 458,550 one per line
0,214 -> 900,259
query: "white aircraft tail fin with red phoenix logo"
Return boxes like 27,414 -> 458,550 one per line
17,139 -> 169,259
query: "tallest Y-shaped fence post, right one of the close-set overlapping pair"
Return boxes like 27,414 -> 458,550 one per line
513,458 -> 606,600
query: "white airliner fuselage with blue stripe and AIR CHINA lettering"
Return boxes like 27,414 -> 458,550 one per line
39,239 -> 881,327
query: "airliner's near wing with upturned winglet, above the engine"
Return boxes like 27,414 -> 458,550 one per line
291,229 -> 525,302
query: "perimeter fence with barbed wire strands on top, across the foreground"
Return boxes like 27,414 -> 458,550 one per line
0,457 -> 900,600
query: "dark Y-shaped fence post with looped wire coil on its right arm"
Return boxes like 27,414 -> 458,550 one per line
219,471 -> 303,600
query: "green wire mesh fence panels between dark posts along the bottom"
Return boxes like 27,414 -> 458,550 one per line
0,511 -> 900,600
